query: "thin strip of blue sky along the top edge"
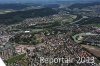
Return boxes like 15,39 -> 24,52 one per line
0,0 -> 100,3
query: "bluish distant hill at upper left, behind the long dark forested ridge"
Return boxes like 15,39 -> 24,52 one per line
0,3 -> 40,10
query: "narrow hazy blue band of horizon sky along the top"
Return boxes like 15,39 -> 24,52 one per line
0,0 -> 100,3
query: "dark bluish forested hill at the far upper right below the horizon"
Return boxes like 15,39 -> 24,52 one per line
69,2 -> 100,9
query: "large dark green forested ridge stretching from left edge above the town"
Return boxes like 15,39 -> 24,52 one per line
0,8 -> 58,25
